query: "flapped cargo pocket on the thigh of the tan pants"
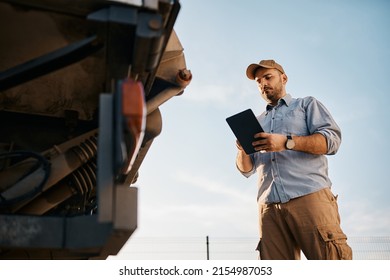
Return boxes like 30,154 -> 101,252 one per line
317,224 -> 352,260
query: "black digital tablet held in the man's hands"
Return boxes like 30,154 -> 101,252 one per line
226,109 -> 264,155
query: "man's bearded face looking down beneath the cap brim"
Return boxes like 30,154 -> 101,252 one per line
255,68 -> 287,105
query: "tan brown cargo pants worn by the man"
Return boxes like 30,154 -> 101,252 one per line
257,188 -> 352,260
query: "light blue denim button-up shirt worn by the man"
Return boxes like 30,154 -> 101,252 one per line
241,94 -> 341,204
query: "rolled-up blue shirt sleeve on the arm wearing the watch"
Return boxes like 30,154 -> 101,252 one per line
306,97 -> 341,155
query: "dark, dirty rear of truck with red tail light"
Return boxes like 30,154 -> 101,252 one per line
0,0 -> 192,260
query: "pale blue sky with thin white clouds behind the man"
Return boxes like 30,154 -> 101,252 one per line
109,0 -> 390,259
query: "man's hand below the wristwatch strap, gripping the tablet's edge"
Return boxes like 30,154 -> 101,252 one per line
252,132 -> 287,152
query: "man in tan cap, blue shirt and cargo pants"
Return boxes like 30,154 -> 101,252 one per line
236,60 -> 352,260
